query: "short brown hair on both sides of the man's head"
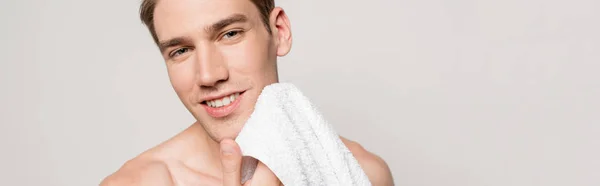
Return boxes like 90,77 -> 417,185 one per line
140,0 -> 275,44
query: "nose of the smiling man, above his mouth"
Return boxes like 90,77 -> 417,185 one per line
196,45 -> 229,87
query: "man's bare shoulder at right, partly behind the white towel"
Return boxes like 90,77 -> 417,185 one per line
340,136 -> 394,186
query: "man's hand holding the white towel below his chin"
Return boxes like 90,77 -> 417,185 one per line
221,139 -> 282,186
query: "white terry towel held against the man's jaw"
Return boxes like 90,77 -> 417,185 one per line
236,83 -> 371,186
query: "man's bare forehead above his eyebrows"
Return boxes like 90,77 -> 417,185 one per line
154,0 -> 258,40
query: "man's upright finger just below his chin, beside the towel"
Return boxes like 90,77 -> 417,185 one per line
221,139 -> 242,186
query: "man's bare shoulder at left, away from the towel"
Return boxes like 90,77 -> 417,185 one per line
100,156 -> 174,186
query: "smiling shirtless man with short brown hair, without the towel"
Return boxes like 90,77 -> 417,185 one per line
101,0 -> 393,186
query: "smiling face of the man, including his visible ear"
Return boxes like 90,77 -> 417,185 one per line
153,0 -> 292,141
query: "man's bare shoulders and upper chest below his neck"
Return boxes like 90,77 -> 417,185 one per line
101,124 -> 393,186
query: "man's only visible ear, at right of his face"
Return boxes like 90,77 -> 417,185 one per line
269,7 -> 292,57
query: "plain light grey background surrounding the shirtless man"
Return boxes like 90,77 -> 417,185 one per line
0,0 -> 600,186
